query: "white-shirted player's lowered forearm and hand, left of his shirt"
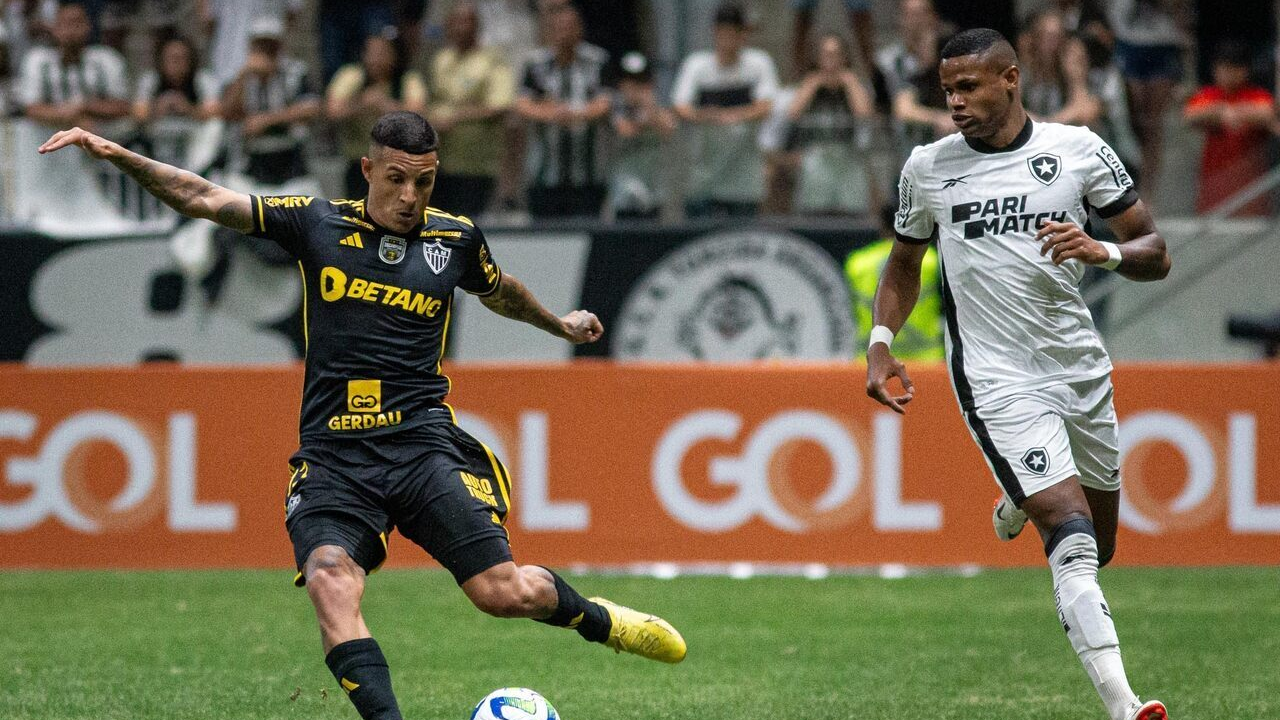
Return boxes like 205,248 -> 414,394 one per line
867,242 -> 929,414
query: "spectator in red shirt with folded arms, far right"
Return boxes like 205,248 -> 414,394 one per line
1183,42 -> 1275,215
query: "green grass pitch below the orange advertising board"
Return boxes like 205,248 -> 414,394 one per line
0,568 -> 1280,720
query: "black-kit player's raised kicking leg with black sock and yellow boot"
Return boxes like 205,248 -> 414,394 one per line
462,562 -> 686,662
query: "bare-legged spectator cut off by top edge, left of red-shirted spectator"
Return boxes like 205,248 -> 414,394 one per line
1108,0 -> 1187,200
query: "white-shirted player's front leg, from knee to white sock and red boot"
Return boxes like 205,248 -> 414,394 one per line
1021,477 -> 1166,720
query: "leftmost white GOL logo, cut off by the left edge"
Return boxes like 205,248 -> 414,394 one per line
0,410 -> 237,533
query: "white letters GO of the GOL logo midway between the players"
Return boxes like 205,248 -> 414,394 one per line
653,410 -> 863,533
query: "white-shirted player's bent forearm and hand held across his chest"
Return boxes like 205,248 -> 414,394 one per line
1036,200 -> 1172,282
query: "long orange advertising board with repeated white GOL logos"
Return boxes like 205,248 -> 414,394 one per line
0,363 -> 1280,568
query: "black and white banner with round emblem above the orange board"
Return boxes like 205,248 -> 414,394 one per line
0,220 -> 876,366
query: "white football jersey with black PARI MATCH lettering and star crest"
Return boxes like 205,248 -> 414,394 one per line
895,120 -> 1138,410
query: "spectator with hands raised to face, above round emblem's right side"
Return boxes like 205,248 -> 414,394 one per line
787,35 -> 878,214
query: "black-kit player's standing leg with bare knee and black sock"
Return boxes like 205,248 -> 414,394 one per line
302,544 -> 401,720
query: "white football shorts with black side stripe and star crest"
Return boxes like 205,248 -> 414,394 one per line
964,375 -> 1120,506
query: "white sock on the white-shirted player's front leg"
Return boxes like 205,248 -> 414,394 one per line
1048,520 -> 1138,720
